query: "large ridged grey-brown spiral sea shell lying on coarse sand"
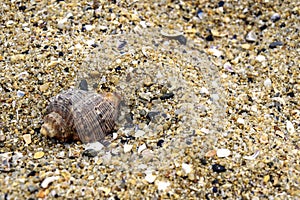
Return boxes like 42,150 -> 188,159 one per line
41,89 -> 120,143
